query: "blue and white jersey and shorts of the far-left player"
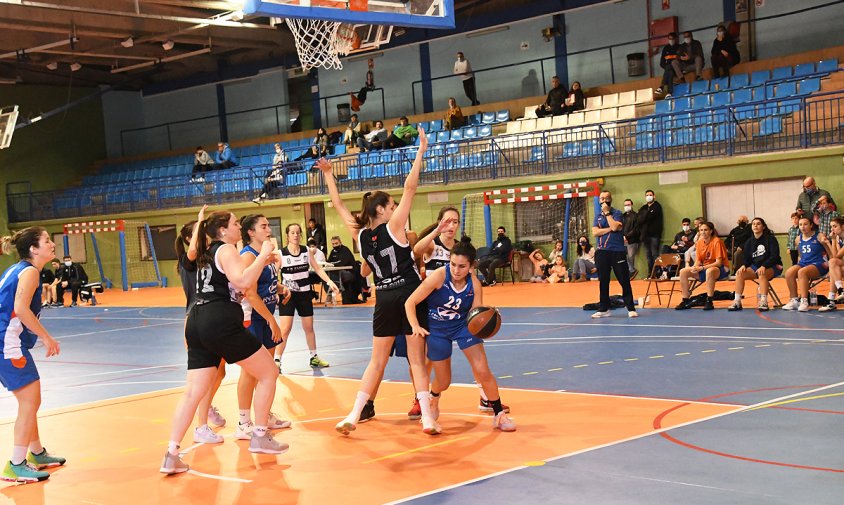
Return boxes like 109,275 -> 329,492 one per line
0,261 -> 41,391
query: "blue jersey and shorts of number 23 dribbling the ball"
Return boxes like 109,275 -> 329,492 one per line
427,267 -> 483,361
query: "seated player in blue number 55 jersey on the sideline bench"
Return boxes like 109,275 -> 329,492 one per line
782,217 -> 831,312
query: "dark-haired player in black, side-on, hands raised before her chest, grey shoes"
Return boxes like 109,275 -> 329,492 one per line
160,207 -> 288,474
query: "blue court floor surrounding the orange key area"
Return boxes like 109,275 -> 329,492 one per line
0,307 -> 844,505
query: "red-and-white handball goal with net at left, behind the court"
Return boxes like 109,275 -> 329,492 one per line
64,219 -> 162,291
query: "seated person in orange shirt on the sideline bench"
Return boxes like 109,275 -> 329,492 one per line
675,221 -> 730,310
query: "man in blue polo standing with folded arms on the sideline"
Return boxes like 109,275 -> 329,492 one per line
592,191 -> 639,319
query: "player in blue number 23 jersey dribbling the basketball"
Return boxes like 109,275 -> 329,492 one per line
404,237 -> 516,431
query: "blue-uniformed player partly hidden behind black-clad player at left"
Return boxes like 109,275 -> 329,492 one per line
234,214 -> 291,441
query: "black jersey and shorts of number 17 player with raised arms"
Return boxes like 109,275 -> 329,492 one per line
358,223 -> 428,337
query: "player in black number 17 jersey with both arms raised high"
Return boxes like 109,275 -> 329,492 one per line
317,129 -> 441,435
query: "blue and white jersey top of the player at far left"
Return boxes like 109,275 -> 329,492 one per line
0,260 -> 41,359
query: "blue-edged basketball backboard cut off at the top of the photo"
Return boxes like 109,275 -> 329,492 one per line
243,0 -> 455,29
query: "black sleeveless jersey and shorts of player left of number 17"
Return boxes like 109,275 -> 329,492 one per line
185,241 -> 261,370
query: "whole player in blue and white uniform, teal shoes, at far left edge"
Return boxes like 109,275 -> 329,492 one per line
0,227 -> 65,482
